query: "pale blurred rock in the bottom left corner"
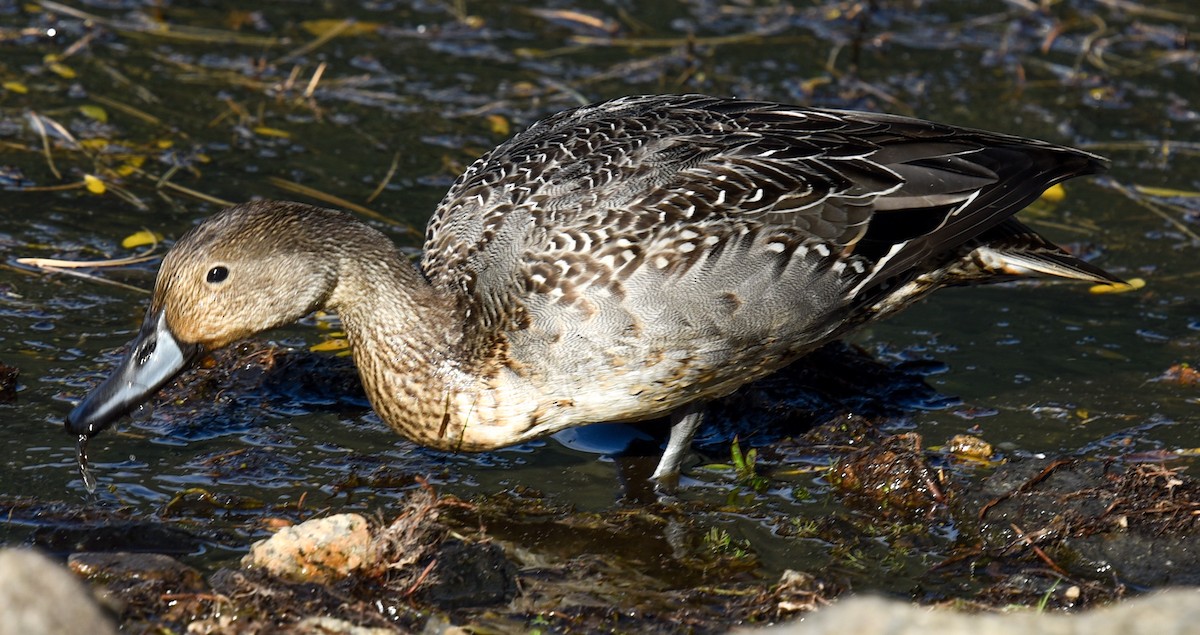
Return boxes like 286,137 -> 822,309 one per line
0,549 -> 116,635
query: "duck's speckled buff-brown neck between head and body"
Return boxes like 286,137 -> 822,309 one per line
326,232 -> 475,445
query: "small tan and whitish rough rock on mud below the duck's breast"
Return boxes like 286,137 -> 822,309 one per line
241,514 -> 376,583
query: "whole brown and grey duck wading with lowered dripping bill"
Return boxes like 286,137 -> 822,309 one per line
65,95 -> 1124,486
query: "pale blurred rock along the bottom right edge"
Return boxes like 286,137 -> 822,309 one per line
733,588 -> 1200,635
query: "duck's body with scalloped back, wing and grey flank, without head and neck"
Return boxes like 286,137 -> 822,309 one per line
421,96 -> 1103,419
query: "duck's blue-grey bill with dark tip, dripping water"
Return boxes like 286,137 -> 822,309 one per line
66,310 -> 203,437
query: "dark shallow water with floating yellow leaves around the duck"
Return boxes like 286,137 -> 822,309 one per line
0,1 -> 1200,602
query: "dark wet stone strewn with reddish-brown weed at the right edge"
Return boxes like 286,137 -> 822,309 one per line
958,460 -> 1200,595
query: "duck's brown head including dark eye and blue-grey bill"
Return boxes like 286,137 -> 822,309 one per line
66,202 -> 343,437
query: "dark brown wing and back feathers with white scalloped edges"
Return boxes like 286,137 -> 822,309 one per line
422,95 -> 1111,324
